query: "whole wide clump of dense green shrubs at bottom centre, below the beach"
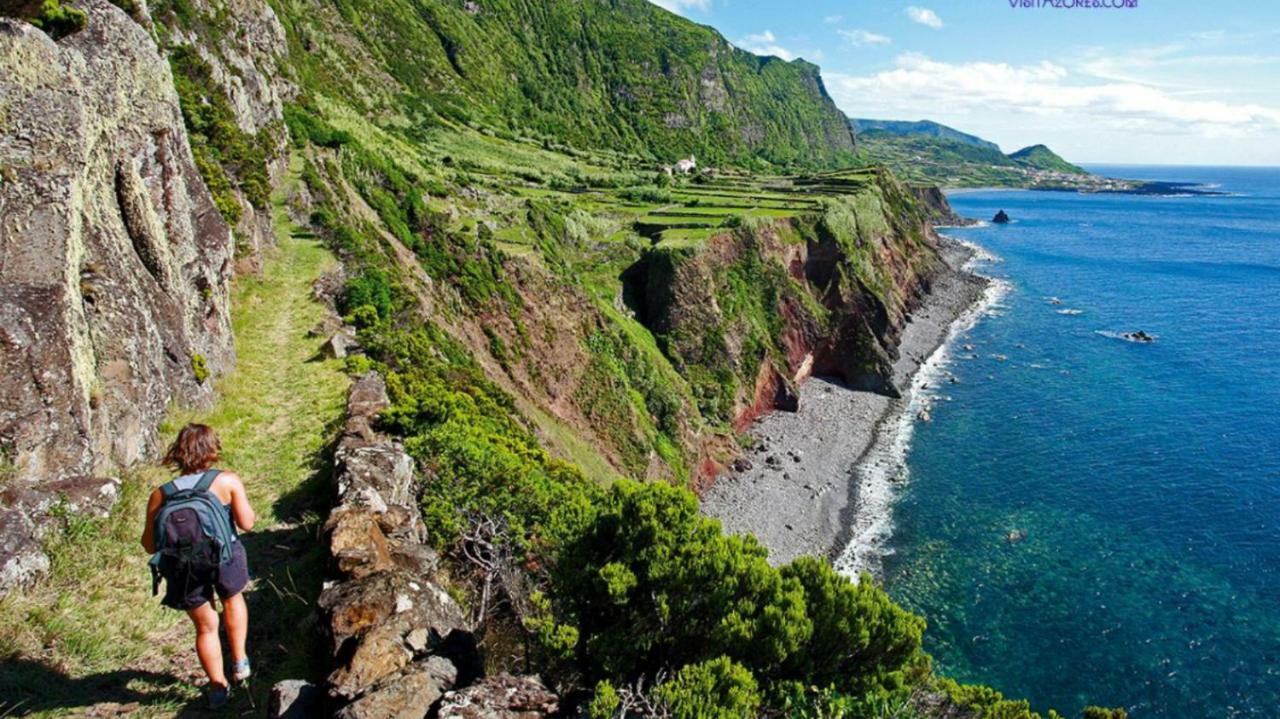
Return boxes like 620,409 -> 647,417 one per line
552,481 -> 924,715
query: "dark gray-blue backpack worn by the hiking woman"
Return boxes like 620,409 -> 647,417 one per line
151,470 -> 239,595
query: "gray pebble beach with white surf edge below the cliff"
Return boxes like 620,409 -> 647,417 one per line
701,237 -> 1000,573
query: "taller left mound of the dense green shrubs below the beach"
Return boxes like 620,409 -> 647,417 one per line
554,481 -> 812,681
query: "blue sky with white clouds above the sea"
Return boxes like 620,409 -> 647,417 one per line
653,0 -> 1280,165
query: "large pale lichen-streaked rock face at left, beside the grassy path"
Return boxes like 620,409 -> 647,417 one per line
0,0 -> 234,587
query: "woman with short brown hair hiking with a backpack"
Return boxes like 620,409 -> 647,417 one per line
142,423 -> 255,709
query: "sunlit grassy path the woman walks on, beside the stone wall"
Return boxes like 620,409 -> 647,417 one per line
0,159 -> 347,715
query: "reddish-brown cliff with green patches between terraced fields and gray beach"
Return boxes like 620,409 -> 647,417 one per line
622,175 -> 945,478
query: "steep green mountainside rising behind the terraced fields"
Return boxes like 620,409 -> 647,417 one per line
261,0 -> 852,166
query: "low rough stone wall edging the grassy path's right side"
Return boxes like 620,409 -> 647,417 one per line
271,372 -> 557,719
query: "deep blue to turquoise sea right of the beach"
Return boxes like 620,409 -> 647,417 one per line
884,166 -> 1280,719
